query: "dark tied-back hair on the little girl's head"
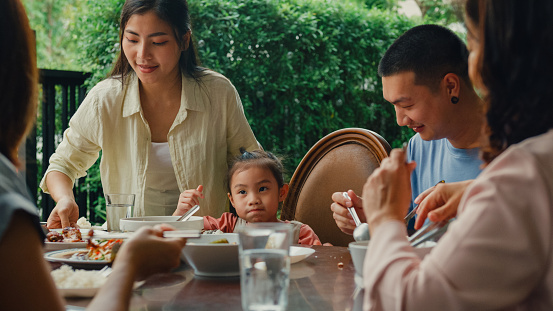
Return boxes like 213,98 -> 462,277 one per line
226,148 -> 284,193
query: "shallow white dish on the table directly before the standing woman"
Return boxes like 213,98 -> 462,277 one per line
119,216 -> 204,231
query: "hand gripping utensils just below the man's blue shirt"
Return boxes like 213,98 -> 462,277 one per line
414,179 -> 473,229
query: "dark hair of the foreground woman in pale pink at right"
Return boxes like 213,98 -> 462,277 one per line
466,0 -> 553,163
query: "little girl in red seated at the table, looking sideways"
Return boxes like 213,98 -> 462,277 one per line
177,149 -> 321,245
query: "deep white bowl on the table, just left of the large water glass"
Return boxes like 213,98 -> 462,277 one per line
182,233 -> 240,277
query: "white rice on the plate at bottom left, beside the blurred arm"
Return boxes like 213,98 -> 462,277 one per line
51,265 -> 106,288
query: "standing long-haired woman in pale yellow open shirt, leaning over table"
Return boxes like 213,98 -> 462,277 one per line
40,0 -> 259,228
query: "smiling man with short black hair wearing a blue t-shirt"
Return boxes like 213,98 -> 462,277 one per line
331,25 -> 484,234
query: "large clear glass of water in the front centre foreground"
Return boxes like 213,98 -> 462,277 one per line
237,222 -> 293,311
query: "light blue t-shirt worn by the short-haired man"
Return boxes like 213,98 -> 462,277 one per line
407,134 -> 482,229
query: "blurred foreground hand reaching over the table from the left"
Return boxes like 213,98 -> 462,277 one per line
113,225 -> 186,280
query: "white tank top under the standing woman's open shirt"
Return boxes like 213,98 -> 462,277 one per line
144,143 -> 180,216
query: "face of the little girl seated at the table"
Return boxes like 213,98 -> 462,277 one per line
228,165 -> 288,222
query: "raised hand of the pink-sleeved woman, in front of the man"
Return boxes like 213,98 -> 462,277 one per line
363,149 -> 416,235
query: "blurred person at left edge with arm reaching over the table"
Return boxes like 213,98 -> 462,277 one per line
0,0 -> 186,311
